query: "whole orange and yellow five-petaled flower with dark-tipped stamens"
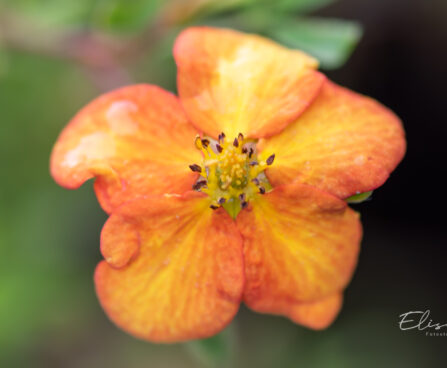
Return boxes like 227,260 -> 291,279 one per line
51,28 -> 405,342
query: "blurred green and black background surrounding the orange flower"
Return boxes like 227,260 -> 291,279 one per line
0,0 -> 447,368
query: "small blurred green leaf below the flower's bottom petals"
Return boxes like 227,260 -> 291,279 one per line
185,325 -> 235,368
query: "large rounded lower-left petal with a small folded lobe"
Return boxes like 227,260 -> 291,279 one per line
95,192 -> 244,342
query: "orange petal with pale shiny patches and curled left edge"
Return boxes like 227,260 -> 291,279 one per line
50,85 -> 201,212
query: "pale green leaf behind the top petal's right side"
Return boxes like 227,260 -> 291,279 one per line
268,18 -> 362,69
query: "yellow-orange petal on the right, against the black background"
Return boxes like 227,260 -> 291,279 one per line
260,81 -> 406,198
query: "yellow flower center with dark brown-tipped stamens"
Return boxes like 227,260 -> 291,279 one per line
189,133 -> 275,218
